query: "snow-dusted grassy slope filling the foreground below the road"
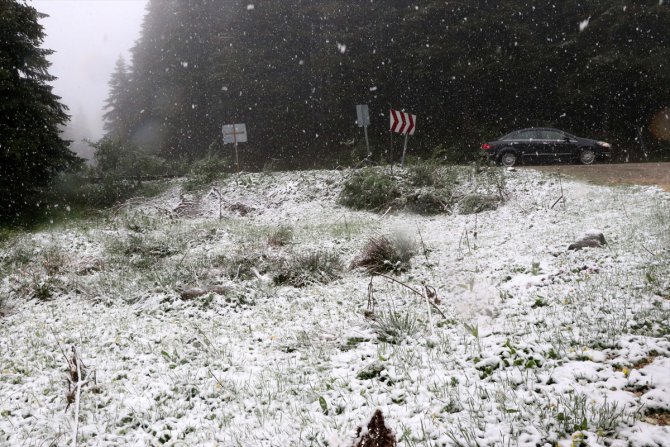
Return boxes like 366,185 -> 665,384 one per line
0,168 -> 670,447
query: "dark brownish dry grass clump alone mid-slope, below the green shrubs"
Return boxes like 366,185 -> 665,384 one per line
352,235 -> 415,274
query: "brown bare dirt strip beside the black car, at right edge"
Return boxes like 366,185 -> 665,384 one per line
524,163 -> 670,192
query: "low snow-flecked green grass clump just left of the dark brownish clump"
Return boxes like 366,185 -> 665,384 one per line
273,251 -> 342,287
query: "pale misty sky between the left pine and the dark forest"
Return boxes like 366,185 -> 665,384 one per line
28,0 -> 147,148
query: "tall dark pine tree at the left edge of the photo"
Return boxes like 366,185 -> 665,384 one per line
0,0 -> 79,222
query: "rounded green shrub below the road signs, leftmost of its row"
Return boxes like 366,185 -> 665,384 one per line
339,168 -> 400,210
